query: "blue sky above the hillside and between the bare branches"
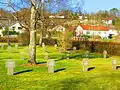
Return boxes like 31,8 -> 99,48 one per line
0,0 -> 120,13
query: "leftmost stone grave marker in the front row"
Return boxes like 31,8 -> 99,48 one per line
6,60 -> 15,75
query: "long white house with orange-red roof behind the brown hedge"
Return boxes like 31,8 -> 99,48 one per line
75,24 -> 117,38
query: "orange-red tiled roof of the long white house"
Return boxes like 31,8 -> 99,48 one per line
80,25 -> 109,31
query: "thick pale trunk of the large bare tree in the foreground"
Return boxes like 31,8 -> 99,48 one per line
28,0 -> 36,64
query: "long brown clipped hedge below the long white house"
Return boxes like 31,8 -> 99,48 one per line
72,41 -> 120,55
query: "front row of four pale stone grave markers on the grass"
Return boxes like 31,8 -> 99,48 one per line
5,58 -> 117,75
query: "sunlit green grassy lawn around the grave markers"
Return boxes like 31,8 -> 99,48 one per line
0,45 -> 120,90
